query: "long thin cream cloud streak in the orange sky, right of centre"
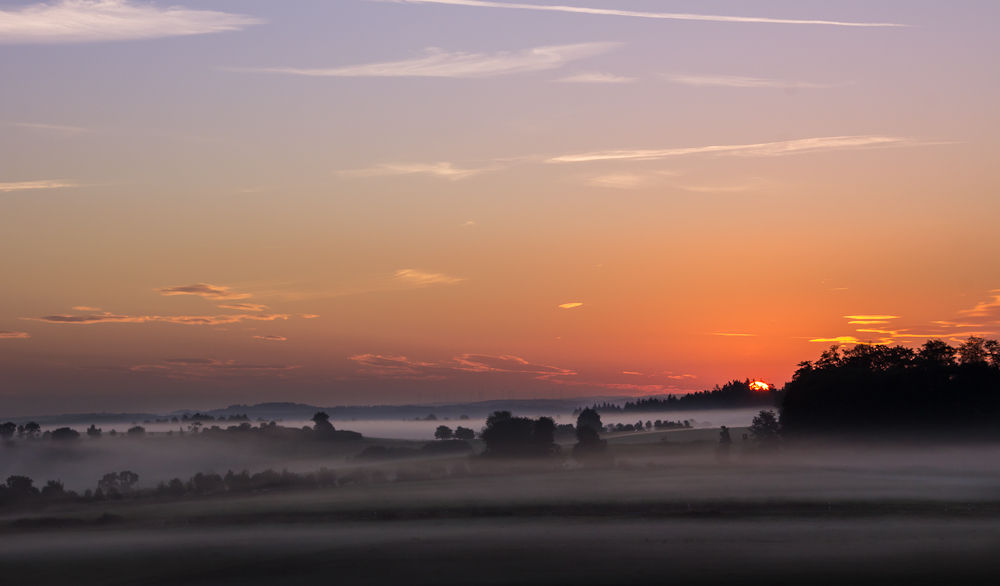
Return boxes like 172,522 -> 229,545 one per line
546,136 -> 918,163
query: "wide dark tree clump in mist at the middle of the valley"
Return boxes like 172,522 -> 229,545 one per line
481,411 -> 559,458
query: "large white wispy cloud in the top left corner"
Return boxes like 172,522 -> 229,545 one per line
0,0 -> 264,44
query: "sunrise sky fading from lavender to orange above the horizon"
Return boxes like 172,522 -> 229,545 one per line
0,0 -> 1000,416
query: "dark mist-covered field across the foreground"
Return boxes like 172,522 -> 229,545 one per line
0,430 -> 1000,584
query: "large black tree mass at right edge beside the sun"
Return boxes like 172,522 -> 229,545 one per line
781,337 -> 1000,437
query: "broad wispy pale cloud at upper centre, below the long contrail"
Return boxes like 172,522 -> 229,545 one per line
235,43 -> 618,78
